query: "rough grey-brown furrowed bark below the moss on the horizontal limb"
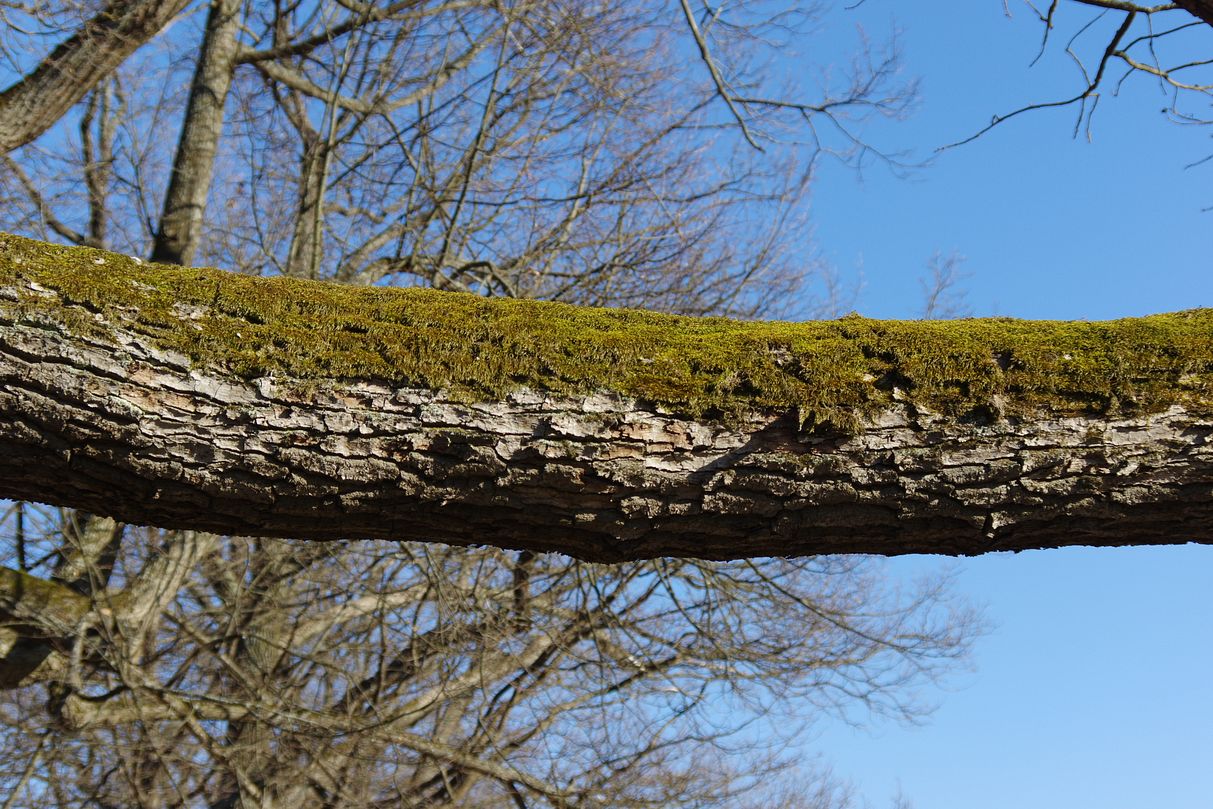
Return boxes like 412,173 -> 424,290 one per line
0,281 -> 1213,560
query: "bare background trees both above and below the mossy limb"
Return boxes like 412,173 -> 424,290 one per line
0,0 -> 975,807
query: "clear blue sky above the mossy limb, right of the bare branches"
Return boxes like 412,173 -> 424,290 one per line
813,0 -> 1213,319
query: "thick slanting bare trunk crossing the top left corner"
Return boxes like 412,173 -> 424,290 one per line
0,0 -> 189,154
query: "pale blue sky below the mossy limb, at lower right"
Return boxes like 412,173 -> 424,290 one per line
804,545 -> 1213,809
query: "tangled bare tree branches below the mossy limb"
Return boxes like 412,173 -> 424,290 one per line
5,519 -> 972,807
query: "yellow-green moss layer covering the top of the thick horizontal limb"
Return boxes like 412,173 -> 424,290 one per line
0,235 -> 1213,431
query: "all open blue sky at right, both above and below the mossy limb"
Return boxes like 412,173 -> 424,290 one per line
790,0 -> 1213,809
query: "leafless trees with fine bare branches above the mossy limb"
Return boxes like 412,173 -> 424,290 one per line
5,2 -> 910,315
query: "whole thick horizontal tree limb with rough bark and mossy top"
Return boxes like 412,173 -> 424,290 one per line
0,237 -> 1213,560
